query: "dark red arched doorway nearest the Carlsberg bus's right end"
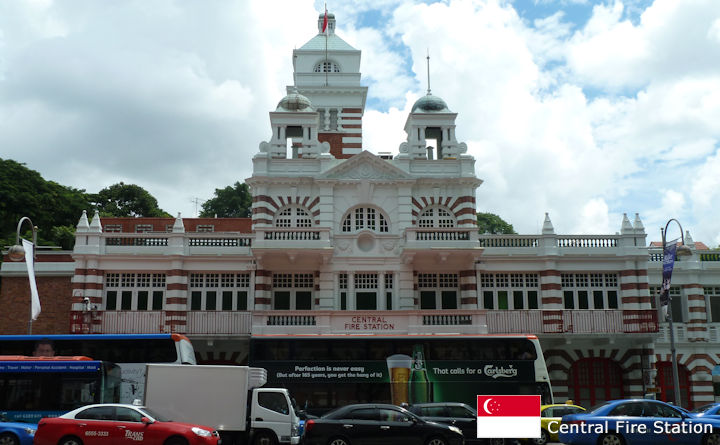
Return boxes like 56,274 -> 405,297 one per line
570,357 -> 624,407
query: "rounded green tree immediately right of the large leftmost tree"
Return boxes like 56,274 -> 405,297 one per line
92,182 -> 170,217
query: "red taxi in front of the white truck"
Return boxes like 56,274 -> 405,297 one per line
33,403 -> 220,445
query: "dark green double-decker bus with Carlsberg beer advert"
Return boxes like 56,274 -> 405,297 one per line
249,334 -> 552,413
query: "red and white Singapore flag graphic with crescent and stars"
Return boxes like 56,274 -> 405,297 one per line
477,396 -> 540,439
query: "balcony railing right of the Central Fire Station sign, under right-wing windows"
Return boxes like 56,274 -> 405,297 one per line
487,310 -> 658,334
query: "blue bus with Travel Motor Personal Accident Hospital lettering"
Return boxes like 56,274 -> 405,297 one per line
0,355 -> 120,423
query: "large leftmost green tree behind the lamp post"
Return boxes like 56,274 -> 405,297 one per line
0,159 -> 92,249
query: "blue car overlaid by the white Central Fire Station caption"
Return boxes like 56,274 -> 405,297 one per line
558,399 -> 720,445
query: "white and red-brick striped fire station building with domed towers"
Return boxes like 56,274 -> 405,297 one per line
0,10 -> 720,406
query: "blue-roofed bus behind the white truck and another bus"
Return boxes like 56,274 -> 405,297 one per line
0,334 -> 197,403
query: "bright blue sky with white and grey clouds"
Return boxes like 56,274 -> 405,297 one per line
0,0 -> 720,247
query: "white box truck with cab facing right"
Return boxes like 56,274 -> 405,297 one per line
144,364 -> 300,445
